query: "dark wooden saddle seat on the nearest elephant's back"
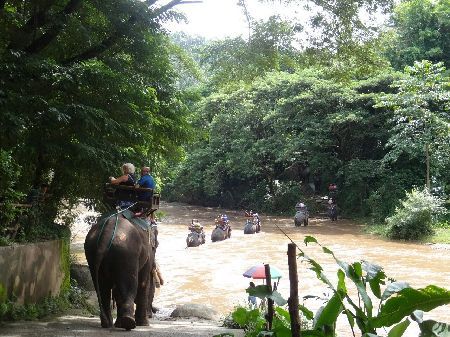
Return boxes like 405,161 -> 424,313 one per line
103,183 -> 160,214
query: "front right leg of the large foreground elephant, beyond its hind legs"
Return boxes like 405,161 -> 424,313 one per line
135,260 -> 154,326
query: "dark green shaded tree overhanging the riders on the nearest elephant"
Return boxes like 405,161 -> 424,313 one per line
0,0 -> 189,232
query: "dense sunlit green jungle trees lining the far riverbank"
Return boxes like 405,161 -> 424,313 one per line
164,1 -> 450,226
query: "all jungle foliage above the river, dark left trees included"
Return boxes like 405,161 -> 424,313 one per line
0,0 -> 450,241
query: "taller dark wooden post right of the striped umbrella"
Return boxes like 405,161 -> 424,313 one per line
287,243 -> 301,337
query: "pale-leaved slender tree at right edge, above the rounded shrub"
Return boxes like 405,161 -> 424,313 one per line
378,61 -> 450,188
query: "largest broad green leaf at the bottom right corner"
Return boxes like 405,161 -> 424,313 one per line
373,285 -> 450,328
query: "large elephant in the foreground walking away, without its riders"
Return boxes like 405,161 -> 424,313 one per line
84,210 -> 158,330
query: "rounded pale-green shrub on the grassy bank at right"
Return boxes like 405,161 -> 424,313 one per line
386,189 -> 445,240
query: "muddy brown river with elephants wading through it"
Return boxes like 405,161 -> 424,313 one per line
72,203 -> 450,336
